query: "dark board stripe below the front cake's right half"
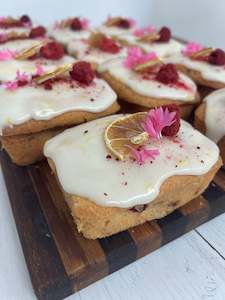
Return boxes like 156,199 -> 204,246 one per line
157,210 -> 188,245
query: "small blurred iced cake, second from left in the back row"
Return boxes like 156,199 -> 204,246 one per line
48,17 -> 90,46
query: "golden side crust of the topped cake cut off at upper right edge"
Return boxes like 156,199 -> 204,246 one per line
176,64 -> 225,89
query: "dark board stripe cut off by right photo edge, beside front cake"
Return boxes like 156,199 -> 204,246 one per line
202,182 -> 225,220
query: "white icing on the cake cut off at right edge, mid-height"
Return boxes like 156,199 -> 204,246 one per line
204,89 -> 225,143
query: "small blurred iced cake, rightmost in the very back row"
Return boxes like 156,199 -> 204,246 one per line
96,16 -> 136,38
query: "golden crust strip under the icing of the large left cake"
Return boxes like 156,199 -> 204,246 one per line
3,102 -> 120,136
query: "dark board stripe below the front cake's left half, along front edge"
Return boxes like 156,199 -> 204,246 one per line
99,231 -> 137,273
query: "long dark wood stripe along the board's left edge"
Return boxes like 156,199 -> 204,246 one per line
0,151 -> 73,299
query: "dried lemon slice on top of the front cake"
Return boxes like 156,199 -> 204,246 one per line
104,112 -> 149,160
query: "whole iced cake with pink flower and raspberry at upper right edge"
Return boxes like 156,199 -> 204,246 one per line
167,43 -> 225,89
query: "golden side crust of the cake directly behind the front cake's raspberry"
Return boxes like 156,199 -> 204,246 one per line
101,72 -> 200,118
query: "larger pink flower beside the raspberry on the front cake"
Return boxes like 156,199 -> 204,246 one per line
142,107 -> 176,139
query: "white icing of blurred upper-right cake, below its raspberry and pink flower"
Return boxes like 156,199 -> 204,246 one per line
119,34 -> 183,57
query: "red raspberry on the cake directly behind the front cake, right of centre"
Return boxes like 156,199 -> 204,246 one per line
156,64 -> 179,84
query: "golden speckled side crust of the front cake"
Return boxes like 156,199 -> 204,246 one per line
48,158 -> 222,239
